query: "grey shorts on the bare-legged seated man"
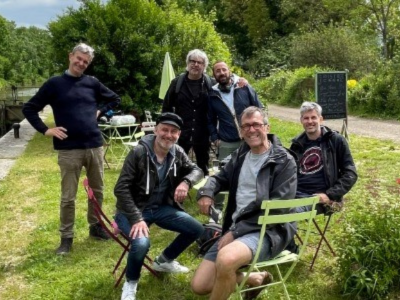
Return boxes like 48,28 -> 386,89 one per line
204,232 -> 271,262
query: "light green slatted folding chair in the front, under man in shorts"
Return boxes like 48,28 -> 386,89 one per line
235,197 -> 318,299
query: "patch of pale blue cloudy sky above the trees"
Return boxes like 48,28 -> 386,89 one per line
0,0 -> 101,29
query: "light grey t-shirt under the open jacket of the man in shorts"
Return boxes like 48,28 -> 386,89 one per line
232,147 -> 271,223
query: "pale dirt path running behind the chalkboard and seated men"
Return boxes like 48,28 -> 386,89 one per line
268,104 -> 400,143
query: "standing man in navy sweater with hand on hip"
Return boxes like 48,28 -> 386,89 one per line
23,43 -> 120,255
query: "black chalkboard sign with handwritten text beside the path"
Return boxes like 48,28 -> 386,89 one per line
315,72 -> 347,119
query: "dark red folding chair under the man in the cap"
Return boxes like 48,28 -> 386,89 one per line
83,178 -> 158,287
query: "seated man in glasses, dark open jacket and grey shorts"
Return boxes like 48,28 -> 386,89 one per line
192,106 -> 297,300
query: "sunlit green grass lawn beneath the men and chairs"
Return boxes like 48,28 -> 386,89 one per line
0,119 -> 400,300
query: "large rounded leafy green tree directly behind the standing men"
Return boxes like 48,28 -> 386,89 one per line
49,0 -> 230,110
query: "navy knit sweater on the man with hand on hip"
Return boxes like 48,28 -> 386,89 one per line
22,73 -> 120,150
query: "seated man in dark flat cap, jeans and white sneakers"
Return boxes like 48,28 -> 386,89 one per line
114,112 -> 203,300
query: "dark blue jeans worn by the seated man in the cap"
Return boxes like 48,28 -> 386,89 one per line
115,205 -> 204,280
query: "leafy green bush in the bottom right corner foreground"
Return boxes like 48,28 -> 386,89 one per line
336,191 -> 400,299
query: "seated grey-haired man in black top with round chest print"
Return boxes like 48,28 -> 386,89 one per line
290,102 -> 357,213
